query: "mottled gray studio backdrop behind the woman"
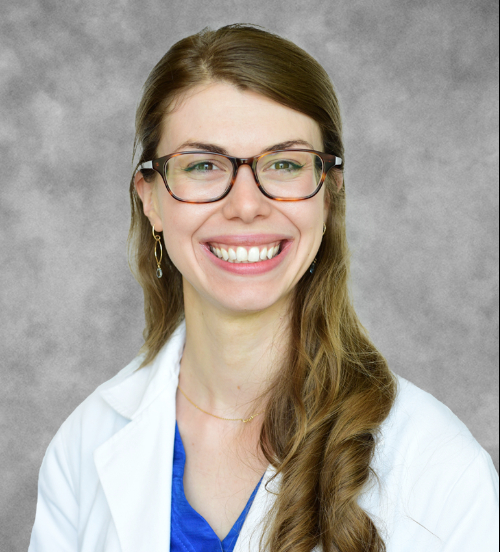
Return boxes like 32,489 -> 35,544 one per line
0,0 -> 498,552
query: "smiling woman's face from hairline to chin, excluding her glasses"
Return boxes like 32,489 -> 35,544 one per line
136,83 -> 328,314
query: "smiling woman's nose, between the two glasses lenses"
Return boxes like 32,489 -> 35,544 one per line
223,163 -> 272,224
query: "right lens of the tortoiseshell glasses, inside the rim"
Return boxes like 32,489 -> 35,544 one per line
257,150 -> 323,199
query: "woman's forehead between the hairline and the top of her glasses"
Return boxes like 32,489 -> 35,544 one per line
158,83 -> 323,157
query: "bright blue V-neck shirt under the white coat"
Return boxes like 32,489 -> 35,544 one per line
170,424 -> 260,552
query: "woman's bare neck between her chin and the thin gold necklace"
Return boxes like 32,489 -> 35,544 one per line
179,283 -> 289,418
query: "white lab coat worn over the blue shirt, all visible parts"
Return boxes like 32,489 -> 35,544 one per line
29,325 -> 499,552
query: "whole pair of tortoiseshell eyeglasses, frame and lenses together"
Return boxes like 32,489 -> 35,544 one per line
139,149 -> 342,203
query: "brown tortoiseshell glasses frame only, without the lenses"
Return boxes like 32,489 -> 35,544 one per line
138,149 -> 342,203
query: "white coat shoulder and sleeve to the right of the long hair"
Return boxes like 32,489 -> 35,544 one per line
363,376 -> 498,551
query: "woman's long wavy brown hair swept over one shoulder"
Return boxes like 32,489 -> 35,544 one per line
129,25 -> 396,552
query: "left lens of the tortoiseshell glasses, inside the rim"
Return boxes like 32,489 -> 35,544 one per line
165,153 -> 233,202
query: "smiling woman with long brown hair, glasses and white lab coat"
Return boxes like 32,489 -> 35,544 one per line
30,25 -> 498,552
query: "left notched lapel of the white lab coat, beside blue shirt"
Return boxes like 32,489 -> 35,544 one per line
94,325 -> 185,552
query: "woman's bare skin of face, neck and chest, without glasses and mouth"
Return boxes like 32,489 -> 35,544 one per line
135,83 -> 338,539
